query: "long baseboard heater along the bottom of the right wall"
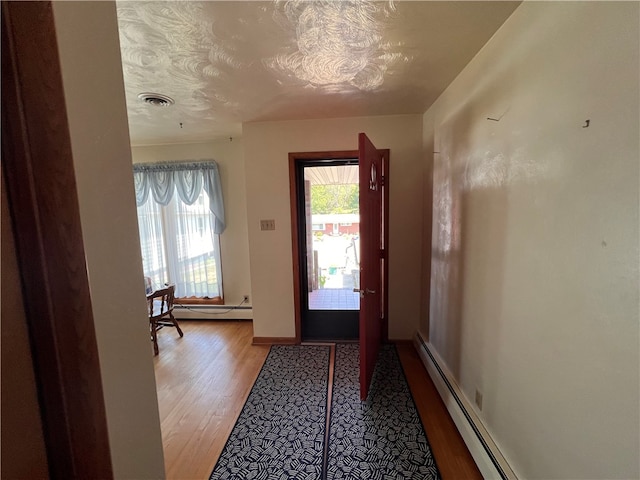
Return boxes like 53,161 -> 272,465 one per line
413,332 -> 518,480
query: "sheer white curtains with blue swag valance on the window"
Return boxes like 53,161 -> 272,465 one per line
134,161 -> 225,298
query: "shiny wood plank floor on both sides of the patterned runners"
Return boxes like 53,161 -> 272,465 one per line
155,321 -> 482,480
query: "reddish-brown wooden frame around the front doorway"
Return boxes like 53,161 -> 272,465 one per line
289,149 -> 389,344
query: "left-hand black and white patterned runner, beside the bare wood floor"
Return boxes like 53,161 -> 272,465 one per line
210,345 -> 330,480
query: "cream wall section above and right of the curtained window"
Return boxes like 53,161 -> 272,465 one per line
131,138 -> 251,306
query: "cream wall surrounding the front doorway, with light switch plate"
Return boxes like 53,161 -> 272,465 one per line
243,115 -> 423,339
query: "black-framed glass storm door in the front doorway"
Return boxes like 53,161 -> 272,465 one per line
295,158 -> 360,341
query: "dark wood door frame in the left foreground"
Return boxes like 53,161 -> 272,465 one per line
2,2 -> 113,479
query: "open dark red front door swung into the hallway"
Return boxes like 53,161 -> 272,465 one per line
358,133 -> 383,400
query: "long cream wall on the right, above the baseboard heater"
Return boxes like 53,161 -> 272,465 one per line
421,2 -> 640,479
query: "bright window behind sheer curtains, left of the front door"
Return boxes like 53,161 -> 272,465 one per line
135,164 -> 224,303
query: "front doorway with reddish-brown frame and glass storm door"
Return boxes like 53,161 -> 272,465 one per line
289,146 -> 389,343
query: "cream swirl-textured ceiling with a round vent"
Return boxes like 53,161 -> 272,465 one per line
117,0 -> 519,145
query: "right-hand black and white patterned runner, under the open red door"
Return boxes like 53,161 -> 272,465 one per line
326,344 -> 440,480
